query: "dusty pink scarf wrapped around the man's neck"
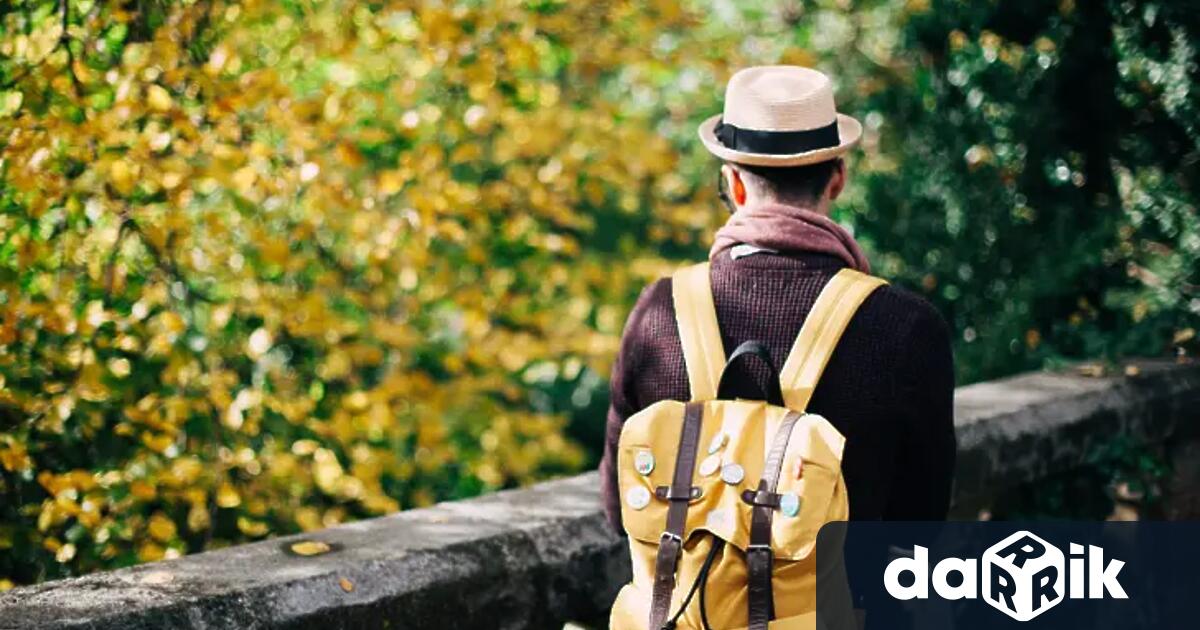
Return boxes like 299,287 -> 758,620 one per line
708,204 -> 871,274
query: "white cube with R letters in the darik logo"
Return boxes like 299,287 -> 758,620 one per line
983,532 -> 1067,622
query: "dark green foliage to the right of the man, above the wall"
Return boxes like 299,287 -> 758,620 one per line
854,0 -> 1200,380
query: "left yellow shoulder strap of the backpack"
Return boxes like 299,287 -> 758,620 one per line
671,263 -> 725,401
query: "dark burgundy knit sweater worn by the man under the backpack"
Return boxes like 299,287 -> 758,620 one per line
600,252 -> 955,532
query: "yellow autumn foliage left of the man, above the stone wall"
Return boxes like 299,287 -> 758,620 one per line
0,0 -> 777,586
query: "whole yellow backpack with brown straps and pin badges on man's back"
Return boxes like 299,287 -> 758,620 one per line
611,263 -> 884,630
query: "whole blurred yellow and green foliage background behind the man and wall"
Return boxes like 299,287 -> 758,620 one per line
0,0 -> 1200,589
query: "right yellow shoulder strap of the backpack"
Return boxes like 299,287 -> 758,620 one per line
779,269 -> 887,412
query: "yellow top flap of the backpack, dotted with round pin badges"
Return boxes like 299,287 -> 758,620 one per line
617,401 -> 848,560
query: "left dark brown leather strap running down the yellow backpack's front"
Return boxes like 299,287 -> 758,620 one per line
649,402 -> 704,630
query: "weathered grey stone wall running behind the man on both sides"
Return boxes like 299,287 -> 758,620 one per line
0,362 -> 1200,630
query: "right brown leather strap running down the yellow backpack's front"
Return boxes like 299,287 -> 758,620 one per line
742,412 -> 804,630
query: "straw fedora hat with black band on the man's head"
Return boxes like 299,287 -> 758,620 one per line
700,66 -> 863,167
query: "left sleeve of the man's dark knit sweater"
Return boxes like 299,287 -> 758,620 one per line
600,280 -> 671,533
